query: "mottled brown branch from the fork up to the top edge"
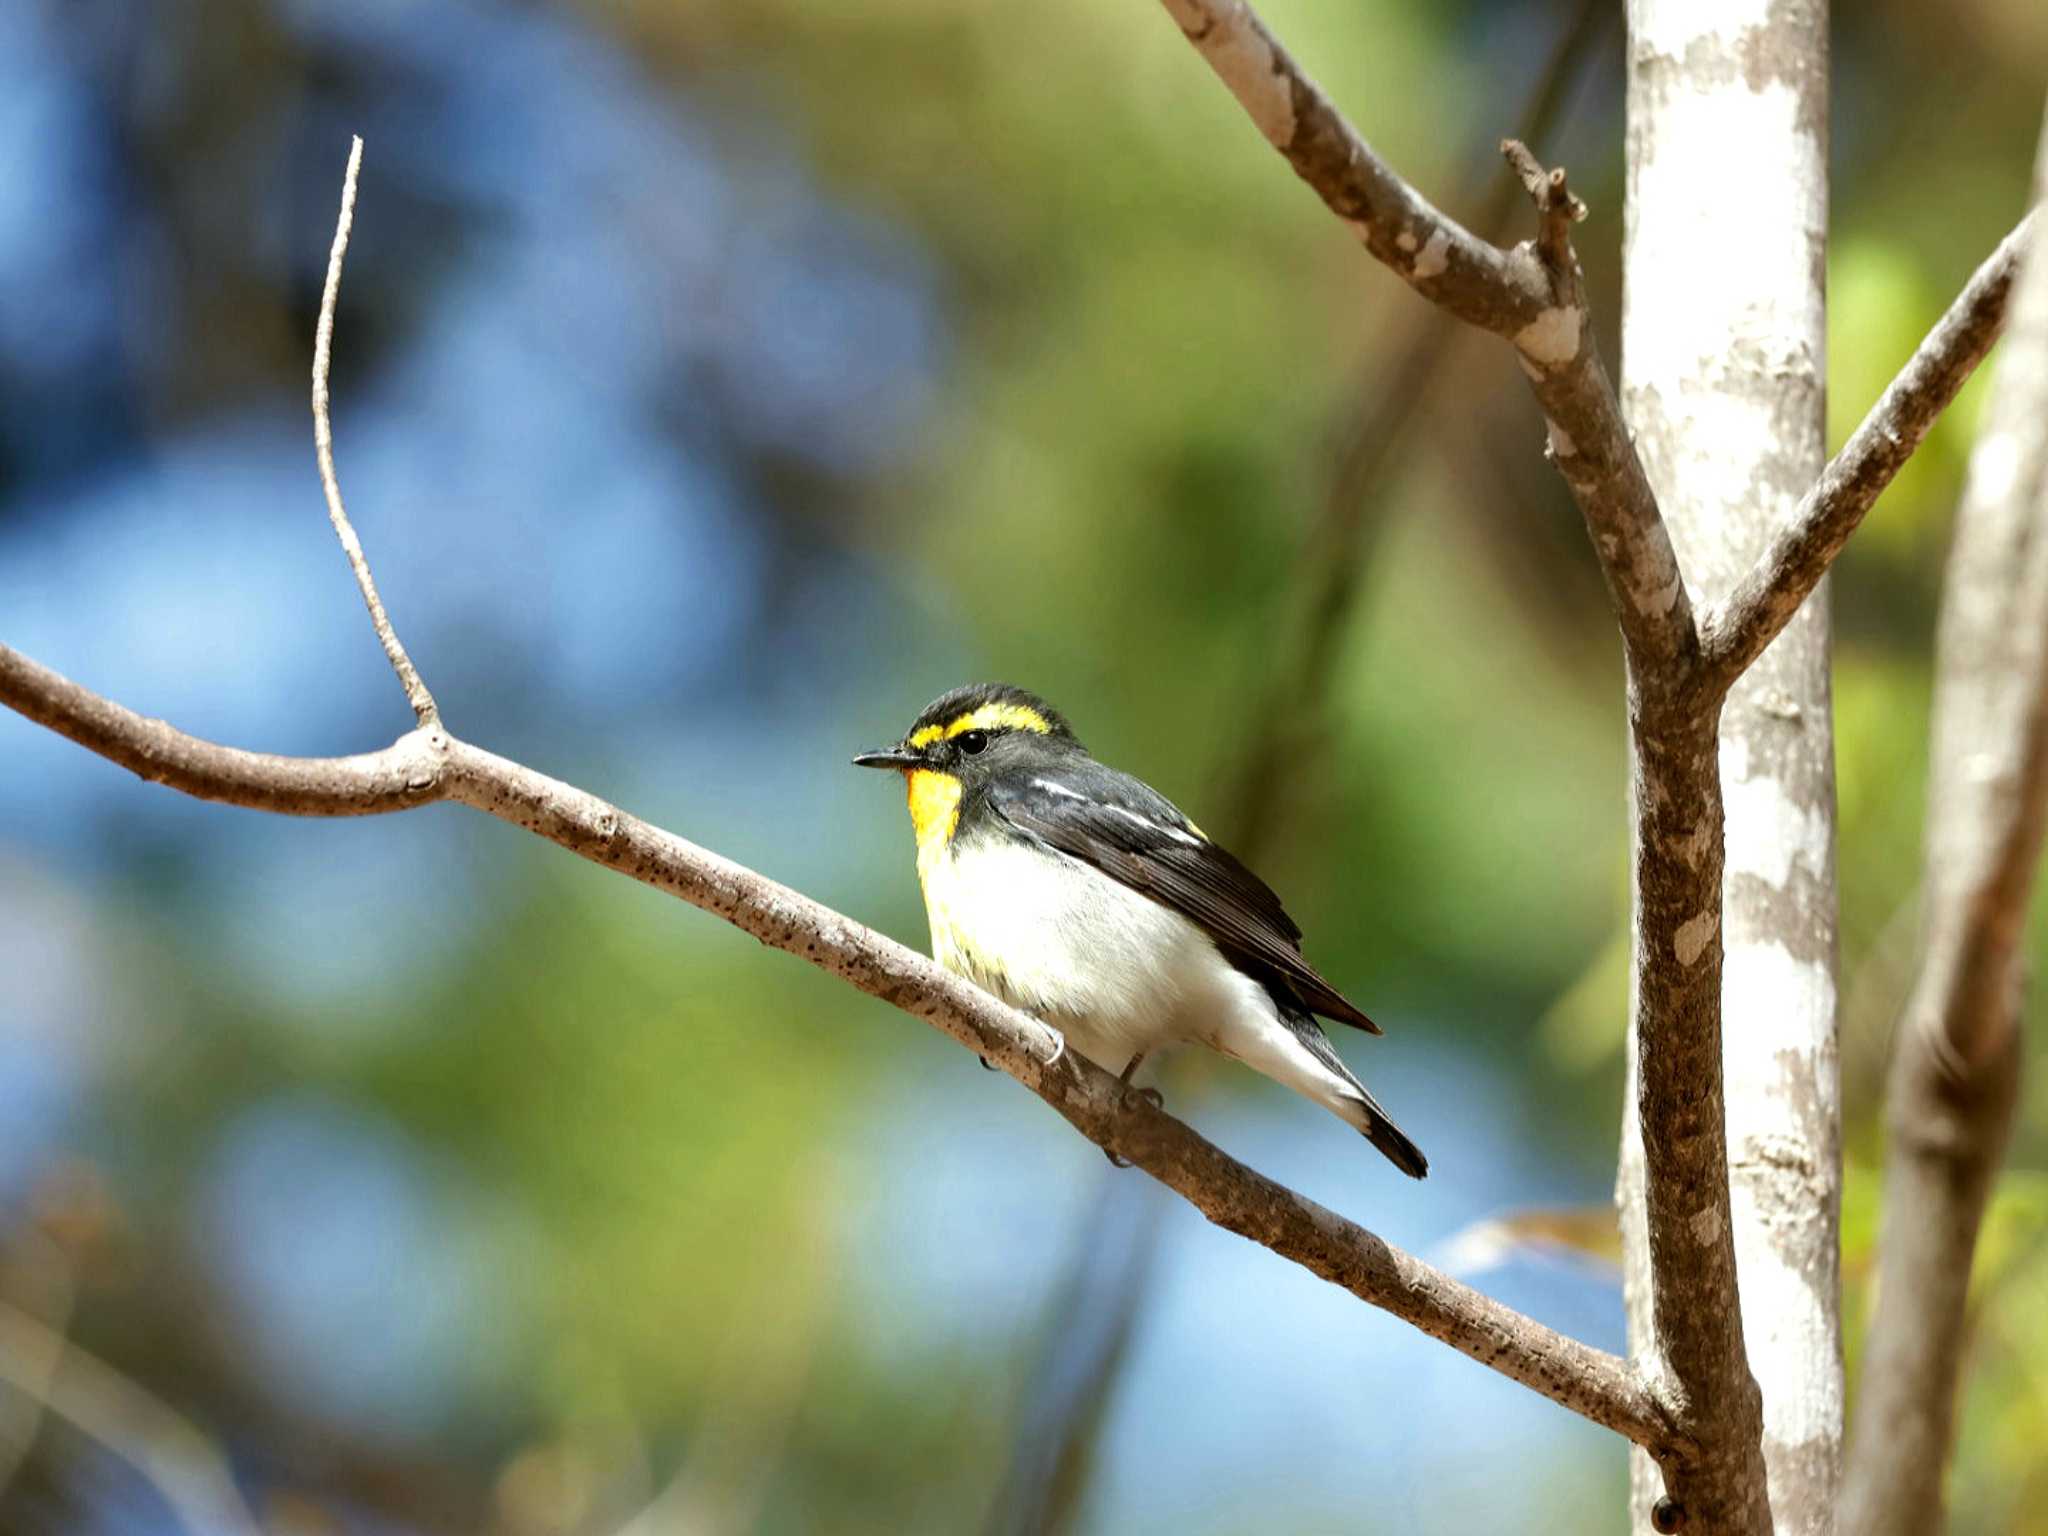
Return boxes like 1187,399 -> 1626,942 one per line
1163,0 -> 1700,690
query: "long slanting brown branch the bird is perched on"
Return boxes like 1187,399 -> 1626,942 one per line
0,645 -> 1690,1462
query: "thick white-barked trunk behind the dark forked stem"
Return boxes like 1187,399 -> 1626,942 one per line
1620,0 -> 1843,1532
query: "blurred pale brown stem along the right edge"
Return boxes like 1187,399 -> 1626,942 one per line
1841,102 -> 2048,1536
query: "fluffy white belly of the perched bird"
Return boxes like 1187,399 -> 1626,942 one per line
924,838 -> 1257,1071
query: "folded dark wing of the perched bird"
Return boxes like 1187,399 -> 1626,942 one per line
987,762 -> 1380,1034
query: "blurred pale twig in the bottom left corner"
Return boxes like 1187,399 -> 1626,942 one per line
0,1303 -> 260,1536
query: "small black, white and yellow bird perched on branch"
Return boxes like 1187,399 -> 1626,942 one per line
854,682 -> 1430,1178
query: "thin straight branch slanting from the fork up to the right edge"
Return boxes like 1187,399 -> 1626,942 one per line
1700,211 -> 2042,686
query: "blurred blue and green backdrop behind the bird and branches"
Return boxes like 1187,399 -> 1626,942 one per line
0,0 -> 2048,1536
